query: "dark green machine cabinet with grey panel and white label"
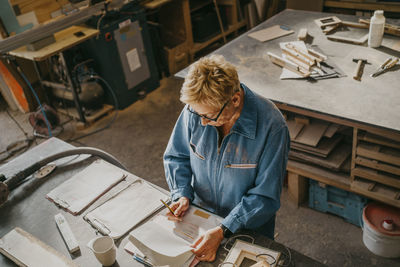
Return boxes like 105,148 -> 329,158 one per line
80,1 -> 160,109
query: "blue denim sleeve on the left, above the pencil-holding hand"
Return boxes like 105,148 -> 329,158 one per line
164,108 -> 194,201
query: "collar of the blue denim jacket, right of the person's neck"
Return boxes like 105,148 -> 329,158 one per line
232,83 -> 258,139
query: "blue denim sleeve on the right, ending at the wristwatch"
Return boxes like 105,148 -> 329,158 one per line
222,125 -> 290,233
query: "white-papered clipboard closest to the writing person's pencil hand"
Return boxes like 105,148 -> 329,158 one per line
84,178 -> 169,239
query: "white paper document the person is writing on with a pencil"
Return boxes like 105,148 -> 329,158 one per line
129,206 -> 222,267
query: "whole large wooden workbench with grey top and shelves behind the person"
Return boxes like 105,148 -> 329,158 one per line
176,10 -> 400,207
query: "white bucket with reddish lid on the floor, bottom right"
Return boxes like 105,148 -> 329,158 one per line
363,203 -> 400,258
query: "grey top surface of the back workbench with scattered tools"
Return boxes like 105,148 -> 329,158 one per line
176,10 -> 400,134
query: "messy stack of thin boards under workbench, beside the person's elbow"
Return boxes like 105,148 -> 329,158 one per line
285,114 -> 351,173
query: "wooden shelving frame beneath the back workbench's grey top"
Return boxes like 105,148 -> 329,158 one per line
282,103 -> 400,207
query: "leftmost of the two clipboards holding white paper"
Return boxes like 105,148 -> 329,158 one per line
46,160 -> 127,215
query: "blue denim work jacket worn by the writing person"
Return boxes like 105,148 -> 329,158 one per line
164,84 -> 290,238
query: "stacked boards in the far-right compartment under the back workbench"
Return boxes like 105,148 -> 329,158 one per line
351,129 -> 400,207
